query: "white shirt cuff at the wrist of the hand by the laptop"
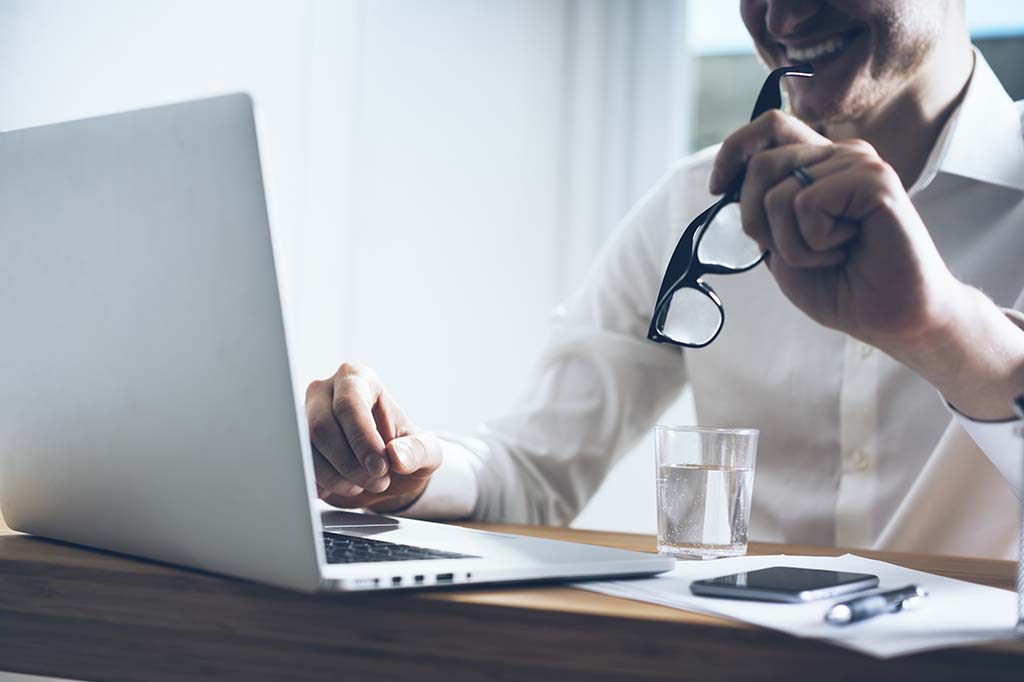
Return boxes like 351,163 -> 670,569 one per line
400,437 -> 478,521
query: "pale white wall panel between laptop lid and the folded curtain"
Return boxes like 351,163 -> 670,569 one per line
344,0 -> 565,430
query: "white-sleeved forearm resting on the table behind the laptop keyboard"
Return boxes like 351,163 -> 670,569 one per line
403,329 -> 685,525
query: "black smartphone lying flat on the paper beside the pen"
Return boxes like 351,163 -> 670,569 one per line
690,566 -> 879,603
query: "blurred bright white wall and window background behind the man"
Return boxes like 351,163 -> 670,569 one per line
0,0 -> 1024,532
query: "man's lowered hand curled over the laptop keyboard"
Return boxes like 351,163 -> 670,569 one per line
306,363 -> 441,513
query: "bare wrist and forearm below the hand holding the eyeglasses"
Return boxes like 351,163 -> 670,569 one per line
884,285 -> 1024,421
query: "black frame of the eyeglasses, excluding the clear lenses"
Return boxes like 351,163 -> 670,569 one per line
647,63 -> 814,348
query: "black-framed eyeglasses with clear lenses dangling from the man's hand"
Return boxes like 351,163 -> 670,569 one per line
647,63 -> 814,348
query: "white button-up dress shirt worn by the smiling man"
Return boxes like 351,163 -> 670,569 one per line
407,51 -> 1024,557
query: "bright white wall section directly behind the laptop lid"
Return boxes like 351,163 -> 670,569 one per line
0,0 -> 355,385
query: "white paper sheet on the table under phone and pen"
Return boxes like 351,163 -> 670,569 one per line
574,554 -> 1017,658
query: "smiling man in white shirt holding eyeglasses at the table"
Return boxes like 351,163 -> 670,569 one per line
306,0 -> 1024,556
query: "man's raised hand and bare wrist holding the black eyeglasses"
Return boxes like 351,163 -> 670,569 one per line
712,113 -> 1024,419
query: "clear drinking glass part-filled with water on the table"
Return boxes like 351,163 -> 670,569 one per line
654,425 -> 760,559
